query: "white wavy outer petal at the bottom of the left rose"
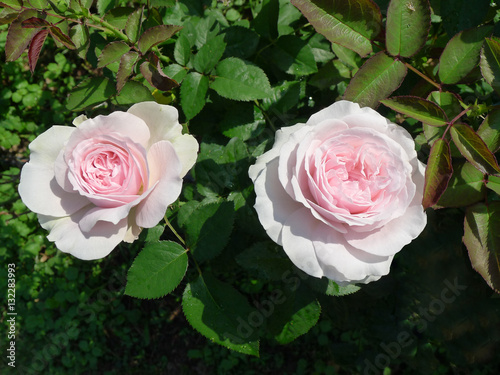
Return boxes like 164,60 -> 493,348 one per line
38,209 -> 127,260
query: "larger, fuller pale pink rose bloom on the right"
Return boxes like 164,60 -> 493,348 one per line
249,101 -> 427,285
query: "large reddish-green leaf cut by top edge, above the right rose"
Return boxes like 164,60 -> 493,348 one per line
291,0 -> 382,56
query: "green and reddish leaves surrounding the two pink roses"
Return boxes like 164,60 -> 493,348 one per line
0,0 -> 500,374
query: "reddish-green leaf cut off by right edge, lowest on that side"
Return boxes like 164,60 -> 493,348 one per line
464,202 -> 500,293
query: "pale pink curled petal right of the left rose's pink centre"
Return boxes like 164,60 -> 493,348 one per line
136,141 -> 182,228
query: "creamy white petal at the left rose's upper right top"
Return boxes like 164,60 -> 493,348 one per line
127,102 -> 182,147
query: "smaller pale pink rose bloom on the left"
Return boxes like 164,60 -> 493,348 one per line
19,102 -> 198,260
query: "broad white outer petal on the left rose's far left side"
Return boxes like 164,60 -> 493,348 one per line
19,126 -> 89,216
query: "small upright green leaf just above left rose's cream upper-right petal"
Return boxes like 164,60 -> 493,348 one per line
181,72 -> 208,120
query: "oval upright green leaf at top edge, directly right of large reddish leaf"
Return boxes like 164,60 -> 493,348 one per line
385,0 -> 431,57
